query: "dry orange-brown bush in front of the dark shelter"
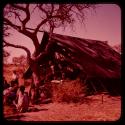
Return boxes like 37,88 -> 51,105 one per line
52,79 -> 86,103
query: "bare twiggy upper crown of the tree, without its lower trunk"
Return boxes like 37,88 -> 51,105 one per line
4,4 -> 96,57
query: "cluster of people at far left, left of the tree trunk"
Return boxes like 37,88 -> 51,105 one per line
3,71 -> 29,112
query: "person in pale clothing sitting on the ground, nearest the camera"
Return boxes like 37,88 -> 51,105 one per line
14,86 -> 29,112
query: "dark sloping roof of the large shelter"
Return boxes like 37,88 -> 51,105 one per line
24,32 -> 121,78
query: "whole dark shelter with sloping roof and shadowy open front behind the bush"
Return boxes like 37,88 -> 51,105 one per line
24,32 -> 121,93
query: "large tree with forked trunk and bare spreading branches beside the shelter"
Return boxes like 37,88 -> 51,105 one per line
3,4 -> 95,86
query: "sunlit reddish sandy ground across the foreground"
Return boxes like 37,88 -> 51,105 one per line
4,95 -> 121,121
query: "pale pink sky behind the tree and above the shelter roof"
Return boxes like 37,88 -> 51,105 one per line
5,4 -> 121,62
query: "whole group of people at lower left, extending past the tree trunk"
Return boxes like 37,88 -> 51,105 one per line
3,71 -> 47,112
